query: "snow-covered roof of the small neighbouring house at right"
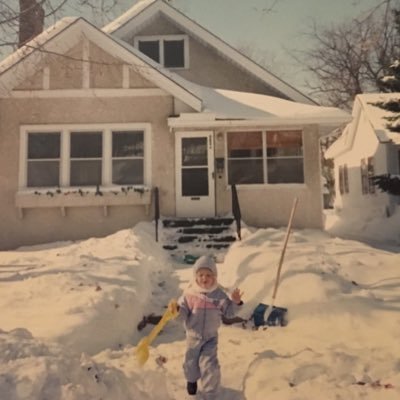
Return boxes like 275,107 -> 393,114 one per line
325,93 -> 400,158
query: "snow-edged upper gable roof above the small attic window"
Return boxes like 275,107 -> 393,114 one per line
103,0 -> 316,104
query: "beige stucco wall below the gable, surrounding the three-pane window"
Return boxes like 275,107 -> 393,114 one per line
0,96 -> 175,249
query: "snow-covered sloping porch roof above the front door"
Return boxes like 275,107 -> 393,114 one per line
169,80 -> 351,127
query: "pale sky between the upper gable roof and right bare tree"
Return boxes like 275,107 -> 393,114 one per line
115,0 -> 381,90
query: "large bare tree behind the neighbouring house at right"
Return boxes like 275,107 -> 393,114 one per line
296,0 -> 400,109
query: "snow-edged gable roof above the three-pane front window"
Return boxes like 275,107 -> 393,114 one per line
0,18 -> 202,111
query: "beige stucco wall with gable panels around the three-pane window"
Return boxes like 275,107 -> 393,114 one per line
0,36 -> 175,249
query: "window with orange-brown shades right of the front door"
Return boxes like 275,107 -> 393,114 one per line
227,130 -> 304,184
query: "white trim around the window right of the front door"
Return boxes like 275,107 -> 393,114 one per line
224,126 -> 306,190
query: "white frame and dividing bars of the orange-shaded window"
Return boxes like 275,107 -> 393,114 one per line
225,127 -> 306,188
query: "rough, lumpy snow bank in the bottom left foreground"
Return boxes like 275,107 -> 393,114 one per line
0,328 -> 146,400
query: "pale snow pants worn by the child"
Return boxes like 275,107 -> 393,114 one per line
183,337 -> 221,400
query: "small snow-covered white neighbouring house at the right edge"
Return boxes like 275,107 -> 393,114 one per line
325,93 -> 400,219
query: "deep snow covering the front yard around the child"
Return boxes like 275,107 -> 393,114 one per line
0,223 -> 400,400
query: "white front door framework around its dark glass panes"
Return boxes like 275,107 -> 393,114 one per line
175,131 -> 215,217
